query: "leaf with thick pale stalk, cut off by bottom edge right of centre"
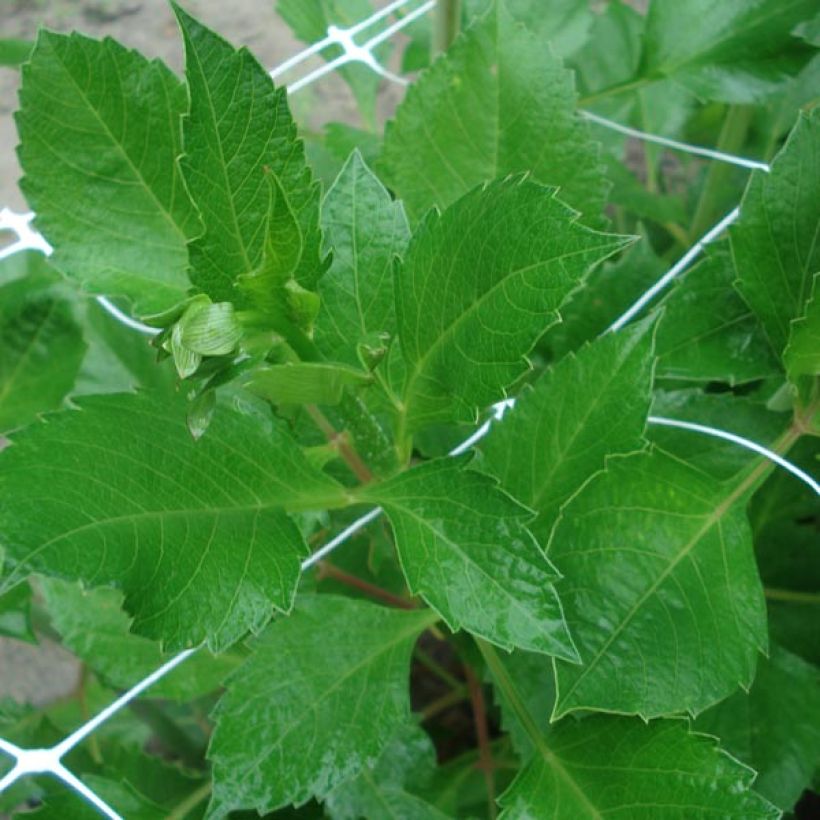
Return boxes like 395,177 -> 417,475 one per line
481,646 -> 778,820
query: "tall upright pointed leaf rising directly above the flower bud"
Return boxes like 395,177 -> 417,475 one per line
174,6 -> 325,303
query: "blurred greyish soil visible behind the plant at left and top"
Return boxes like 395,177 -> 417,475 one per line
0,0 -> 401,705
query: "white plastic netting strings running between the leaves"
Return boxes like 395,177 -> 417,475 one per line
0,0 -> 820,818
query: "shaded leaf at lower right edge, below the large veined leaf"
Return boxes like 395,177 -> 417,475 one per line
695,647 -> 820,812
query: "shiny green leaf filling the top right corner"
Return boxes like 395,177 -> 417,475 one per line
641,0 -> 817,103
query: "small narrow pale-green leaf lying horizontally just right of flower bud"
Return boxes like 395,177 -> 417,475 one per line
244,362 -> 372,404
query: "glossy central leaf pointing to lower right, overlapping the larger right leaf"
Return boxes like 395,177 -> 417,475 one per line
360,458 -> 576,662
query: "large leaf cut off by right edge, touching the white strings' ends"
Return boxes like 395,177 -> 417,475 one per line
730,110 -> 820,356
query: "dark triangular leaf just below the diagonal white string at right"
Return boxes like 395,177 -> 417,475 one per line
657,243 -> 780,385
